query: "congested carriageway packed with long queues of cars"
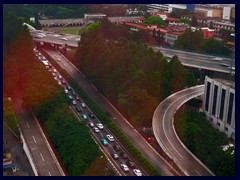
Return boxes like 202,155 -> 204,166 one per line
35,50 -> 147,176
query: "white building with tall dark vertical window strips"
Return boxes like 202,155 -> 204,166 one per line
203,76 -> 235,140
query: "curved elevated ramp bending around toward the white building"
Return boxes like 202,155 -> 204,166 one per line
152,85 -> 213,176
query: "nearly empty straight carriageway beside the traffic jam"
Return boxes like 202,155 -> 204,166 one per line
44,49 -> 179,176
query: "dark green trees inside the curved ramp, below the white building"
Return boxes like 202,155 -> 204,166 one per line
174,110 -> 235,176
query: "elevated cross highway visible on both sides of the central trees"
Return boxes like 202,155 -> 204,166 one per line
30,30 -> 235,74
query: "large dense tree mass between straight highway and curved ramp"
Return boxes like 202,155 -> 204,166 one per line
75,20 -> 197,126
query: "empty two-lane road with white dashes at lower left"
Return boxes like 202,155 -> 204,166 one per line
14,94 -> 61,176
